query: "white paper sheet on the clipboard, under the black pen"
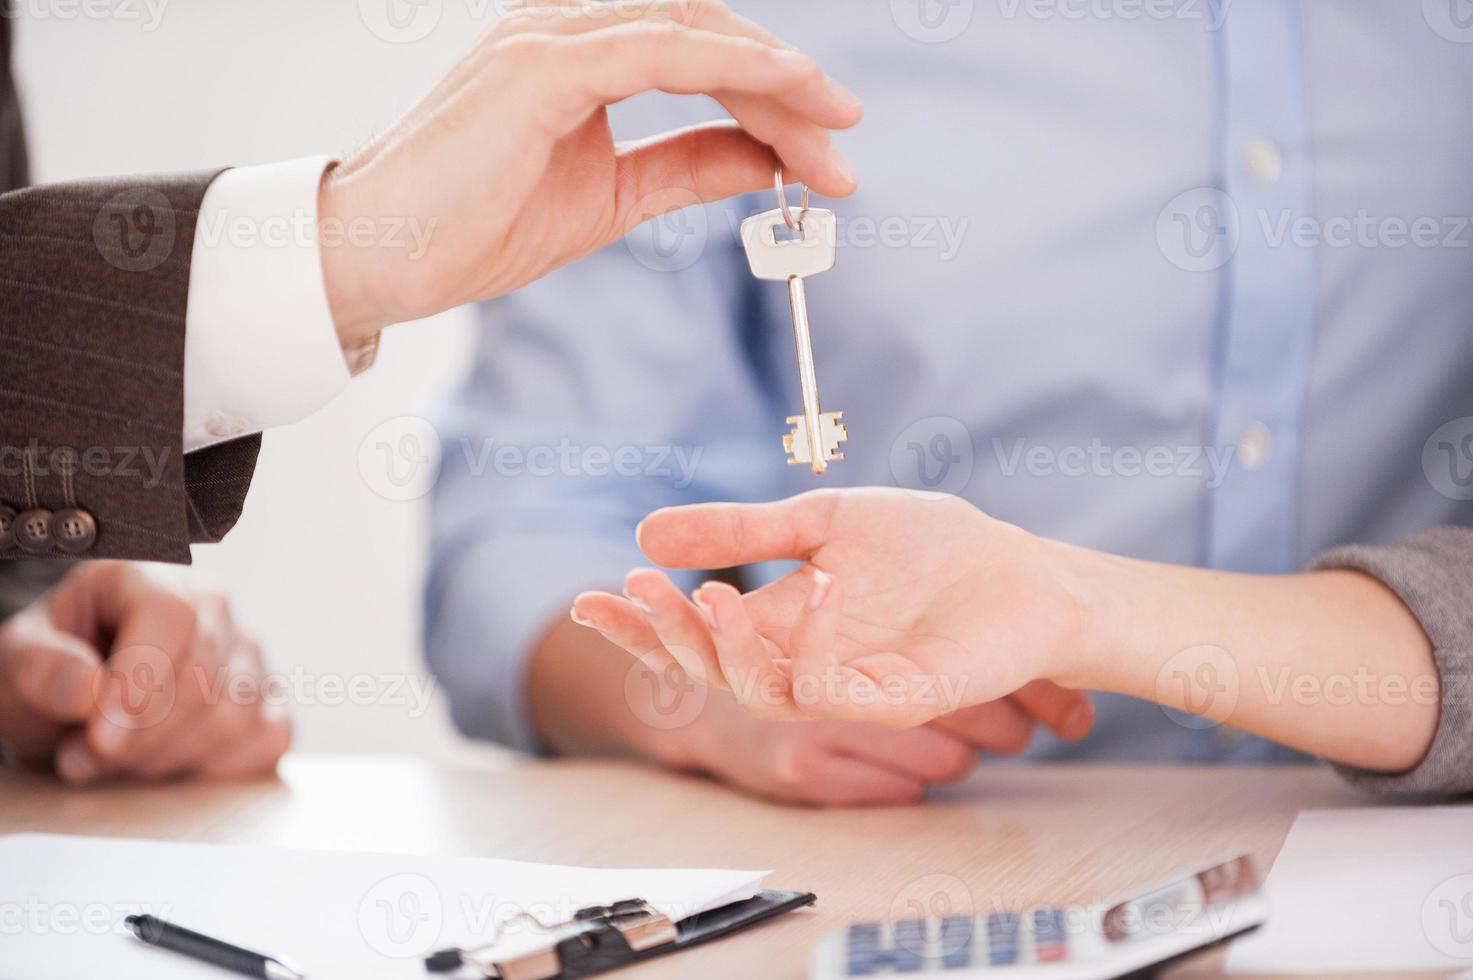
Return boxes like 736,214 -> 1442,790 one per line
0,834 -> 767,980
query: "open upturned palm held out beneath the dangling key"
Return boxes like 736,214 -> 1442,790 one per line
574,489 -> 1090,727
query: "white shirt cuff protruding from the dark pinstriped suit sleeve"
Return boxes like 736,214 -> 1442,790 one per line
184,156 -> 349,452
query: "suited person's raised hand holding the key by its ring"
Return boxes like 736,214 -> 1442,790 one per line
321,0 -> 863,348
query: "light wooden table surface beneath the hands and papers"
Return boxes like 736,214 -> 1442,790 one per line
0,756 -> 1390,980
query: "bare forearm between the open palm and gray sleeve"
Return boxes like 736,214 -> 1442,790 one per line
1064,551 -> 1441,772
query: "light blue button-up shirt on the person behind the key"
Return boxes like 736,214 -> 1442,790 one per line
427,0 -> 1473,762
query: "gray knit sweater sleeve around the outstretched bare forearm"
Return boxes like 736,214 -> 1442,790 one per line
1312,528 -> 1473,799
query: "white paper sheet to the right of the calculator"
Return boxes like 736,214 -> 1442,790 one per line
1227,806 -> 1473,974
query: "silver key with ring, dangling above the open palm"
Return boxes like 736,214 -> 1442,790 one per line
741,169 -> 848,476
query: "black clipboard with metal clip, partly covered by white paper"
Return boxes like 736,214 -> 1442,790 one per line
424,892 -> 818,980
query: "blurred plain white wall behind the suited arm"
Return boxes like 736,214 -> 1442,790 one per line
10,0 -> 509,757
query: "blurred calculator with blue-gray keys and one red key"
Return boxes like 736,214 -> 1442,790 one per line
810,855 -> 1268,980
